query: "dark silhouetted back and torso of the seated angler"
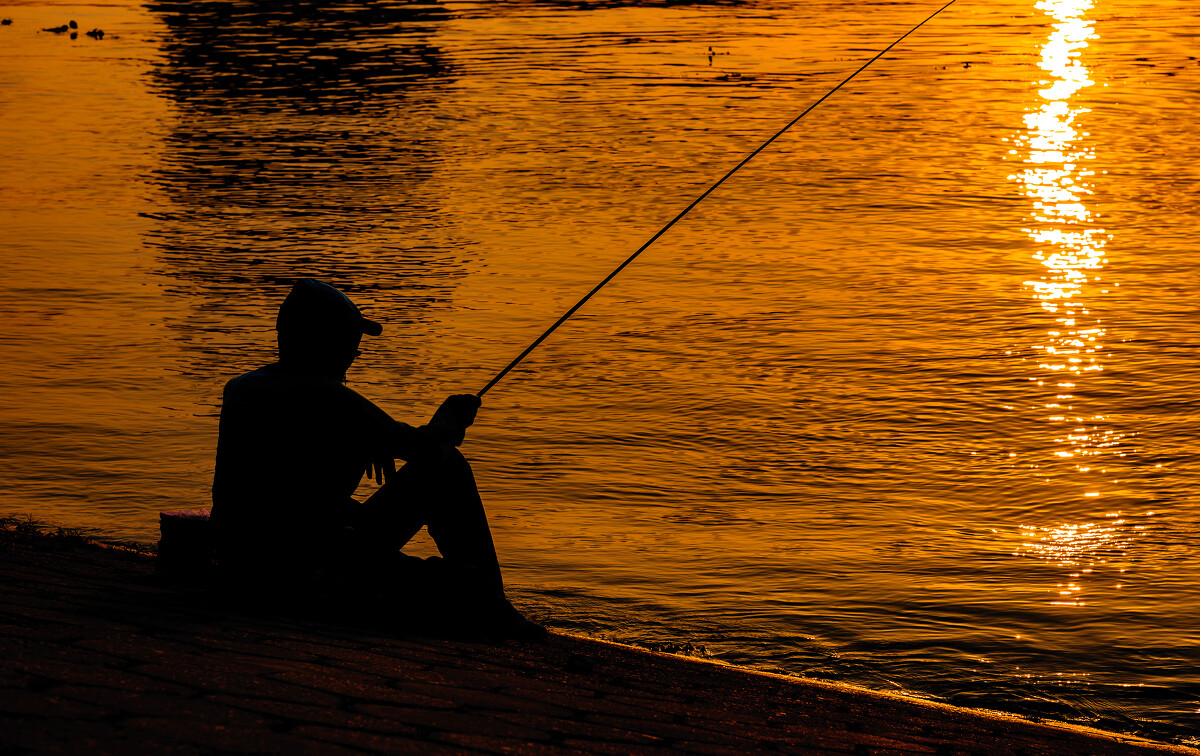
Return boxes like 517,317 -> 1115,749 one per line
212,362 -> 398,577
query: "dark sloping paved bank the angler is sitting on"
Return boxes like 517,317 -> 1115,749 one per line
0,533 -> 1200,756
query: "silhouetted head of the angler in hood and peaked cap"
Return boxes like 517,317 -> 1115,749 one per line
275,278 -> 383,378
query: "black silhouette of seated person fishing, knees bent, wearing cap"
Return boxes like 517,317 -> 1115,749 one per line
212,278 -> 545,637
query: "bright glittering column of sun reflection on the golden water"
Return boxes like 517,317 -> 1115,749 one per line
1008,0 -> 1129,606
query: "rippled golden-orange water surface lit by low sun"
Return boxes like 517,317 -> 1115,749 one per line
0,0 -> 1200,743
